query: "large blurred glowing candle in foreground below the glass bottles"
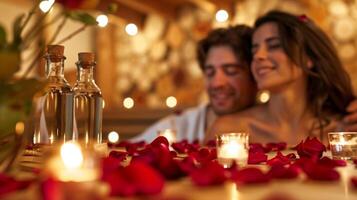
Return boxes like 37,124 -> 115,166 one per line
46,142 -> 108,200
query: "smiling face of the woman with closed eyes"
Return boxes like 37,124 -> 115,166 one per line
251,22 -> 303,92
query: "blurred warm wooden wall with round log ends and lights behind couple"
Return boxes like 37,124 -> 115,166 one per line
0,0 -> 357,138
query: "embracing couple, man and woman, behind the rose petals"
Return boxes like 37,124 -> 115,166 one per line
134,11 -> 357,144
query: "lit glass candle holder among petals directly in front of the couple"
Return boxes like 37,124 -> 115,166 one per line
216,133 -> 249,168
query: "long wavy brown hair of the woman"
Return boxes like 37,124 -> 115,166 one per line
254,11 -> 354,139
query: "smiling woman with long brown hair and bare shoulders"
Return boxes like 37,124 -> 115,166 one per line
207,11 -> 354,144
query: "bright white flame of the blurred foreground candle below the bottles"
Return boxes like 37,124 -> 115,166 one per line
61,142 -> 83,169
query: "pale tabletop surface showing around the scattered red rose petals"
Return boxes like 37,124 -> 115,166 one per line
5,148 -> 357,200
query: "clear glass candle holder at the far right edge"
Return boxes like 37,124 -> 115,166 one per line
328,132 -> 357,160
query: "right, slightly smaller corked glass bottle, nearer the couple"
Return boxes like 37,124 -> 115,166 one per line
73,52 -> 103,146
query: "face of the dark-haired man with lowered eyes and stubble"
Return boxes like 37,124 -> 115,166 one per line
203,46 -> 256,115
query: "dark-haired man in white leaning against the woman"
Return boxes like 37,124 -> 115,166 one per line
132,25 -> 357,142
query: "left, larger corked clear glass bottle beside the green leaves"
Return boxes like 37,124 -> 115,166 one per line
33,45 -> 73,144
